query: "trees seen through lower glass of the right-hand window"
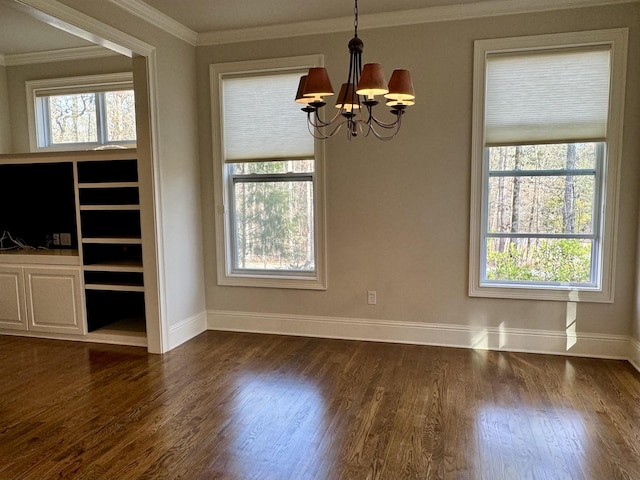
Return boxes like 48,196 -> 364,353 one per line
485,143 -> 604,285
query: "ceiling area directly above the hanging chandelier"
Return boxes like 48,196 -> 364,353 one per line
144,0 -> 482,33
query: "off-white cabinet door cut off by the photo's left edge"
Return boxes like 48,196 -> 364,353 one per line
0,266 -> 28,330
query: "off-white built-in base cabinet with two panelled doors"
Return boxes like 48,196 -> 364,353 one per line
0,265 -> 87,335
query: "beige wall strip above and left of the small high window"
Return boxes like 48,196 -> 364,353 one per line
5,55 -> 131,153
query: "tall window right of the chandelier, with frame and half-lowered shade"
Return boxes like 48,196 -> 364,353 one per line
469,29 -> 627,302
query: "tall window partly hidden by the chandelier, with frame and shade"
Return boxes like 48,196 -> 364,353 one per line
210,56 -> 326,289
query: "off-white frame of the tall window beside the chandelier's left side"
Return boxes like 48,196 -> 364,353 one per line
209,55 -> 327,290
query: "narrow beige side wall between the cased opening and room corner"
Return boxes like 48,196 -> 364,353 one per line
55,0 -> 205,336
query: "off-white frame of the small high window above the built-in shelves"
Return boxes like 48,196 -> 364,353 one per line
25,72 -> 137,152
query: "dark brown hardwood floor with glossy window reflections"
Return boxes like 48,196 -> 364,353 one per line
0,332 -> 640,480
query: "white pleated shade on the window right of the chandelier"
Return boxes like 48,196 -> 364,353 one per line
485,48 -> 610,146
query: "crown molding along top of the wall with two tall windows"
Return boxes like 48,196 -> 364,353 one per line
196,0 -> 640,46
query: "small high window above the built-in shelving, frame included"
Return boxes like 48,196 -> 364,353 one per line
27,73 -> 136,151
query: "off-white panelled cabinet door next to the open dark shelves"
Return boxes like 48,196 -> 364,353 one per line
24,267 -> 87,335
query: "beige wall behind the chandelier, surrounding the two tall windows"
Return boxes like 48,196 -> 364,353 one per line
197,3 -> 640,335
